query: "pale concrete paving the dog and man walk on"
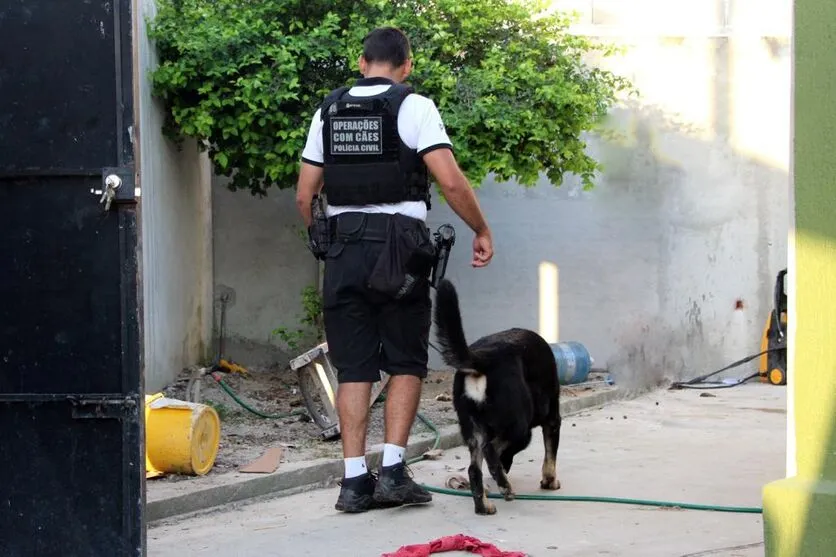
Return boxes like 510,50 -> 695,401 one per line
148,384 -> 786,557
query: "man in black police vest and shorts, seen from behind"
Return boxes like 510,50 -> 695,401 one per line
296,27 -> 493,512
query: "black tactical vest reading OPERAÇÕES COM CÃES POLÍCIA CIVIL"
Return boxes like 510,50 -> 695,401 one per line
322,84 -> 430,208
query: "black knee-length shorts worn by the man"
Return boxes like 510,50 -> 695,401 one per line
322,213 -> 432,383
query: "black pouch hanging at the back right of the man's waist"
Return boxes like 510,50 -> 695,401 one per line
368,214 -> 435,300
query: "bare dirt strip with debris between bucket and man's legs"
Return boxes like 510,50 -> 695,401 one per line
164,367 -> 456,480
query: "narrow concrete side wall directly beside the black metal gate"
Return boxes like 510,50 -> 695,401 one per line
134,0 -> 212,392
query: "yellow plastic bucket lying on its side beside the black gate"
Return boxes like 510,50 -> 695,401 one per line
145,393 -> 221,478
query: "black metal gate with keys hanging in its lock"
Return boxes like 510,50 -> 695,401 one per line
0,0 -> 145,557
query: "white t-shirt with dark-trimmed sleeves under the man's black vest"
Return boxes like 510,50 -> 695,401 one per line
302,78 -> 453,221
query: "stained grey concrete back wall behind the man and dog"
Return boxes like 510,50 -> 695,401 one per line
215,0 -> 790,386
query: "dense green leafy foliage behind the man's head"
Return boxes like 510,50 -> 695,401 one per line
149,0 -> 630,195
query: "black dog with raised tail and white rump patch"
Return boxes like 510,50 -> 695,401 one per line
435,280 -> 561,514
